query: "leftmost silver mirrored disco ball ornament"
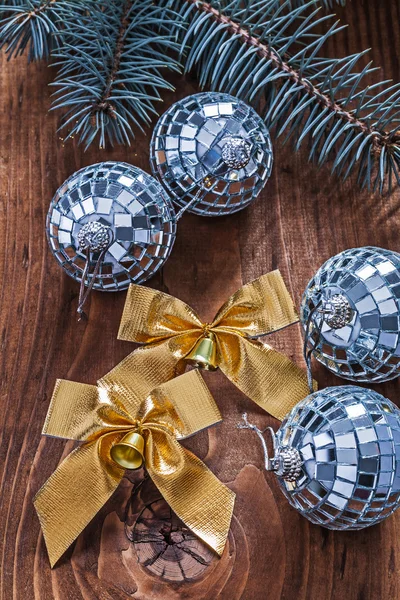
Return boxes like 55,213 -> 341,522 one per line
46,161 -> 176,292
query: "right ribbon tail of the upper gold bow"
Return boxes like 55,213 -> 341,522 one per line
218,333 -> 310,421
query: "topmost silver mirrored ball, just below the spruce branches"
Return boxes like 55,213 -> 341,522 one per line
150,92 -> 272,216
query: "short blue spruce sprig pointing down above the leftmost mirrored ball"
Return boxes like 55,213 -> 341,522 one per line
53,0 -> 179,147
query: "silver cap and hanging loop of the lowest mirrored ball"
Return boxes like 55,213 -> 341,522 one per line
238,413 -> 303,482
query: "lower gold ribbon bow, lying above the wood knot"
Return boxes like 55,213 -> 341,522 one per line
34,371 -> 235,566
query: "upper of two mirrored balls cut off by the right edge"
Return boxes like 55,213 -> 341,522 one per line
300,247 -> 400,382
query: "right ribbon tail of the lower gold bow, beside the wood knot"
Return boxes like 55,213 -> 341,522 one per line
146,432 -> 235,556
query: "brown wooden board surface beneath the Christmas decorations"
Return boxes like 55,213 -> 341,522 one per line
0,0 -> 400,600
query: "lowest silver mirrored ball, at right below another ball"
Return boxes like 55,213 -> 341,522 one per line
270,386 -> 400,529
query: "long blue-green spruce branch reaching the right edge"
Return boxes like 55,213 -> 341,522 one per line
162,0 -> 400,192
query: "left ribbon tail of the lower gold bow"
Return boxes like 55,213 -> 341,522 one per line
33,436 -> 124,567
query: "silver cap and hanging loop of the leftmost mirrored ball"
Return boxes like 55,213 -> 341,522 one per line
76,221 -> 114,321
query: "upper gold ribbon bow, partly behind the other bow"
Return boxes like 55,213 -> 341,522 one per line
117,271 -> 309,420
